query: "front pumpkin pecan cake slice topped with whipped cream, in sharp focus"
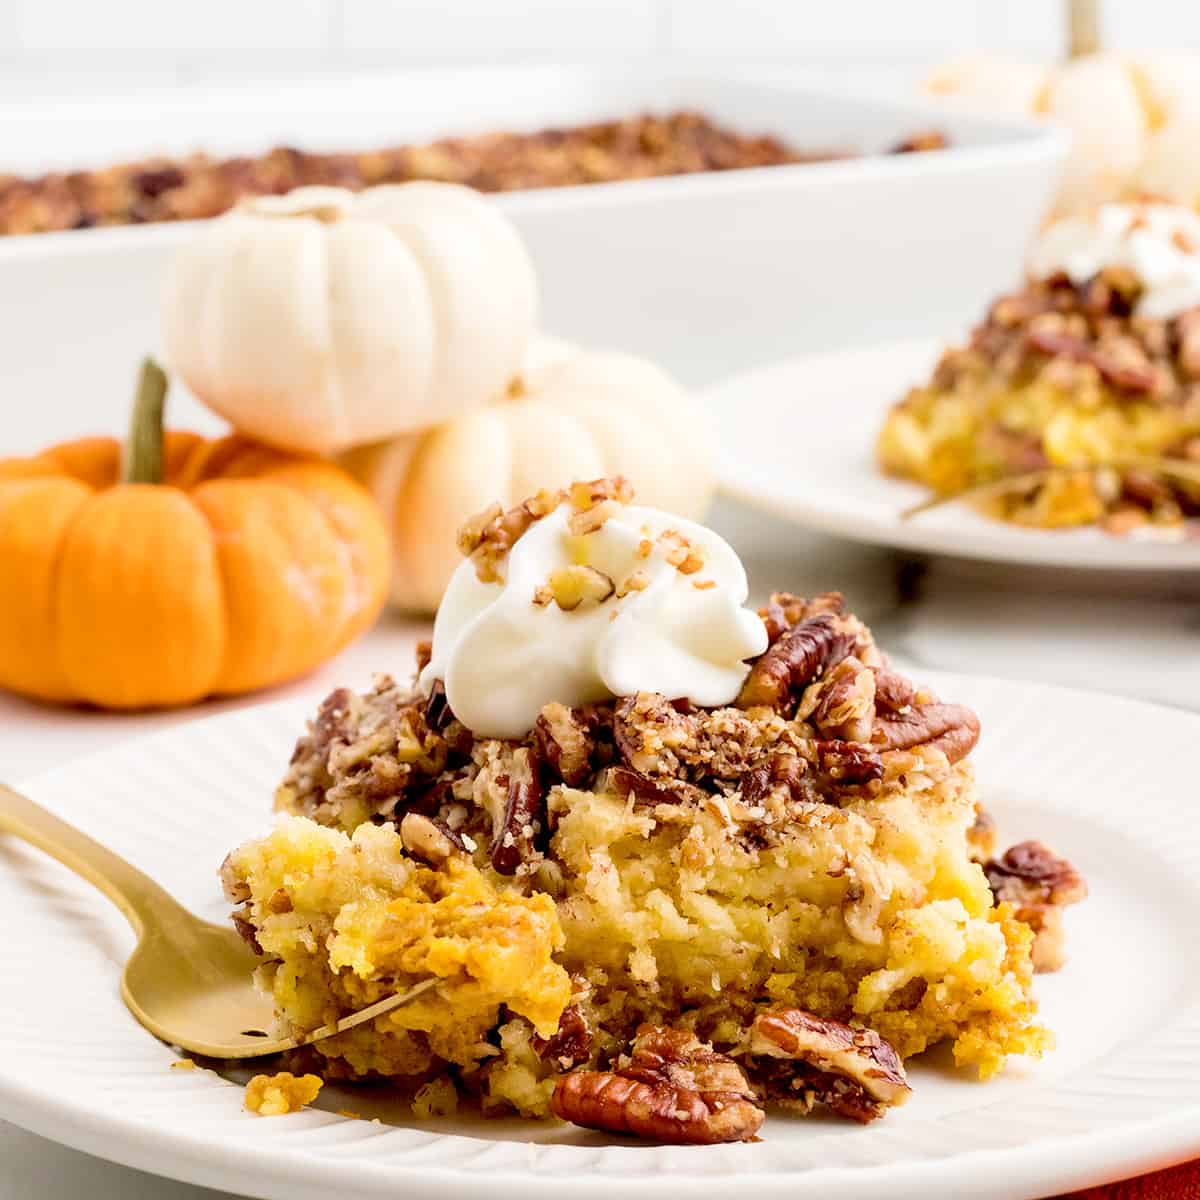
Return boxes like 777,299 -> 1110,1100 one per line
223,480 -> 1082,1142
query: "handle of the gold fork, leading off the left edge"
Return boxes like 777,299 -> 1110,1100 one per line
0,784 -> 180,937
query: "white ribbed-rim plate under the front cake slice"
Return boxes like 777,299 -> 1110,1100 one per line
0,677 -> 1200,1200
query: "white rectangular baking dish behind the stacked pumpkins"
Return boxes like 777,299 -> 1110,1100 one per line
0,64 -> 1064,452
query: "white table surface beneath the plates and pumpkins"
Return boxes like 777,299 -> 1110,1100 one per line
0,504 -> 1200,1200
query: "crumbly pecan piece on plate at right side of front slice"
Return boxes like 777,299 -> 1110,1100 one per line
983,841 -> 1087,971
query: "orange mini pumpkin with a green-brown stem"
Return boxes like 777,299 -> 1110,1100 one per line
0,362 -> 389,708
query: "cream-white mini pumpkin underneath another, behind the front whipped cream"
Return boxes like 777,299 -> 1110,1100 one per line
341,341 -> 715,612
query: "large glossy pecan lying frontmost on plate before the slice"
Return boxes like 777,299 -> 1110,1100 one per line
551,1025 -> 764,1146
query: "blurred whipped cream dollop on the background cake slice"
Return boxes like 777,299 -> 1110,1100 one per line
1028,204 -> 1200,319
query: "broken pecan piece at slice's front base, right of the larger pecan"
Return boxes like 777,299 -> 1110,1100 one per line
748,1008 -> 912,1124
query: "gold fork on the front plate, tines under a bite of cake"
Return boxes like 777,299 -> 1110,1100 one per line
0,784 -> 437,1058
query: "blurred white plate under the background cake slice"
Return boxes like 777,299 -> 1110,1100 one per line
704,338 -> 1200,571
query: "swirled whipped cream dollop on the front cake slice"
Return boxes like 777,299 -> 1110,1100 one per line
420,500 -> 767,738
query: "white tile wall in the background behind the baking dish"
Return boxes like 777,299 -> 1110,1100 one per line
0,0 -> 1200,103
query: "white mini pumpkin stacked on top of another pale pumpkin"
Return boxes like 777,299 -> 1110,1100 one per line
163,182 -> 538,452
